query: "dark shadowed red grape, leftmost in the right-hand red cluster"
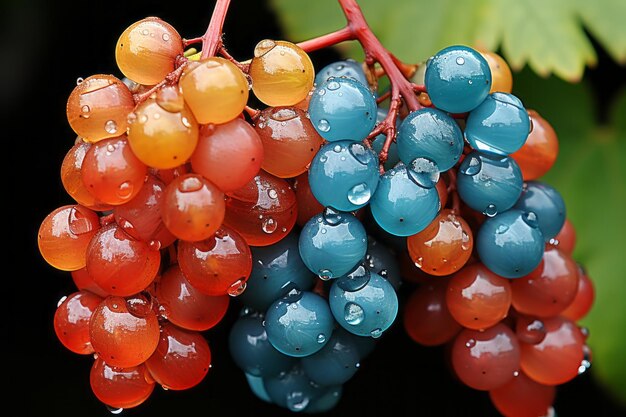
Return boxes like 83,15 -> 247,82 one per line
403,279 -> 462,346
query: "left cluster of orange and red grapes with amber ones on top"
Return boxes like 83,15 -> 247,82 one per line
38,17 -> 323,408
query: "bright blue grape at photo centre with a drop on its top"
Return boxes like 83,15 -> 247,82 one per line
299,208 -> 367,280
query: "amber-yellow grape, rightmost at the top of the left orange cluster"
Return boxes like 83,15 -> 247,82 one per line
248,39 -> 315,106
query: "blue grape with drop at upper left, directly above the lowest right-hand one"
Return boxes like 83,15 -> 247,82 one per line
456,151 -> 524,217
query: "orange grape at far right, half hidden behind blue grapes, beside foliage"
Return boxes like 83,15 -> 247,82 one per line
511,109 -> 559,181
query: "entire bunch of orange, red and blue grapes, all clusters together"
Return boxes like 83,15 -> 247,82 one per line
38,0 -> 593,416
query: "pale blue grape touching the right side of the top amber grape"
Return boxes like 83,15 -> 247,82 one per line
309,77 -> 377,142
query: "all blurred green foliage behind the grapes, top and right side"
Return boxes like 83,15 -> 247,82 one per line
272,0 -> 626,402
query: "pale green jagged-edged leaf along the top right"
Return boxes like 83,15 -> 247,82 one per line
272,0 -> 626,81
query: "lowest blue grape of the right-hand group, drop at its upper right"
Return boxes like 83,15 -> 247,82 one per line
476,209 -> 544,278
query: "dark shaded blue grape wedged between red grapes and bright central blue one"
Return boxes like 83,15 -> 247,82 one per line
239,232 -> 315,312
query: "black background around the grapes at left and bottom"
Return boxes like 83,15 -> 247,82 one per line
0,0 -> 626,417
